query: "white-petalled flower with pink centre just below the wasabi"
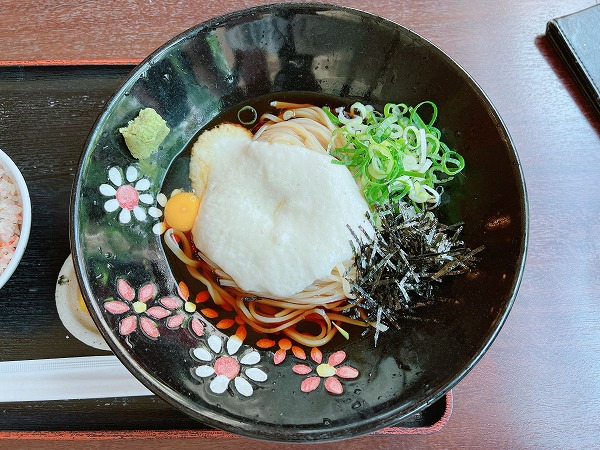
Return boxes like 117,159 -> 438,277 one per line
100,166 -> 162,224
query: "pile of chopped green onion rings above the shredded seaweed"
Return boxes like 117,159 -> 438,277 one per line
323,101 -> 465,210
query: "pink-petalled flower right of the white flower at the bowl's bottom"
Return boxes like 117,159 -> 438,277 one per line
292,347 -> 359,395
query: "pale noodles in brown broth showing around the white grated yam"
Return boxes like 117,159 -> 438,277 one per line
165,102 -> 371,347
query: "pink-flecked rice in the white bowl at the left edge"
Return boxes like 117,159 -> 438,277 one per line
0,166 -> 23,274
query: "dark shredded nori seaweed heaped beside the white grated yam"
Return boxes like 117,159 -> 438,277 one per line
346,202 -> 484,334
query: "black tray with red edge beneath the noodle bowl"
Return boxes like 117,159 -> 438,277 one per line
0,66 -> 452,437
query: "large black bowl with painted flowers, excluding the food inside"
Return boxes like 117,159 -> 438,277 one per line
72,3 -> 527,441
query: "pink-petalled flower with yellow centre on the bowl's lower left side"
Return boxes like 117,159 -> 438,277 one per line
103,278 -> 171,339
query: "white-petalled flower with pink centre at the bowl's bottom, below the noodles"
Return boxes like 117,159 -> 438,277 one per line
193,334 -> 267,397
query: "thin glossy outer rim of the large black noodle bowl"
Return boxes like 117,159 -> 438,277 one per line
69,2 -> 530,443
